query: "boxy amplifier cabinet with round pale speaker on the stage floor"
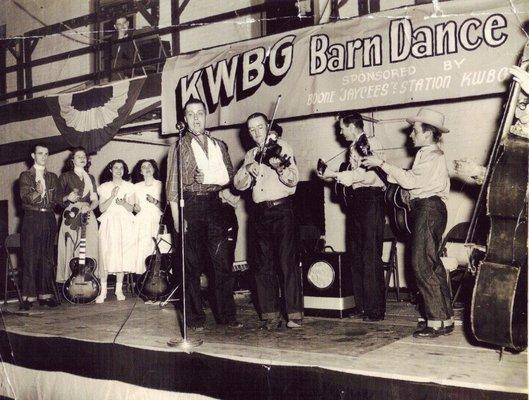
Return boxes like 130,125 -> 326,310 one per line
301,252 -> 355,318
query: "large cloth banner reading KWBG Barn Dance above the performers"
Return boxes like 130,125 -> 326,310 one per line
162,0 -> 529,134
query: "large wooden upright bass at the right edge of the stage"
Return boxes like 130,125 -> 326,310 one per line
466,43 -> 529,351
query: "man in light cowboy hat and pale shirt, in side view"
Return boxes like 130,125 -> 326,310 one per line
362,108 -> 454,338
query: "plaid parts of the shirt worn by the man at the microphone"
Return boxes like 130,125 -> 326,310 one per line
166,131 -> 233,201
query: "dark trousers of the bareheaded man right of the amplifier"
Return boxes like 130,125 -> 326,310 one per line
347,188 -> 386,315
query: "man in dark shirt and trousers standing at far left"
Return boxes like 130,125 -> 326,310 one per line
19,144 -> 61,311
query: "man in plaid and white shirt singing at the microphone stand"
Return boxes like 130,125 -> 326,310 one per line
166,98 -> 242,331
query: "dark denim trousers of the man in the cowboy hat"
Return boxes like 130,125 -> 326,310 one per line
410,196 -> 454,321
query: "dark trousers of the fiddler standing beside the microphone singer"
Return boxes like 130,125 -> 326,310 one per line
251,201 -> 303,319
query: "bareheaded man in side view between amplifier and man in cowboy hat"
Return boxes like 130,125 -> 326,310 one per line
318,112 -> 386,321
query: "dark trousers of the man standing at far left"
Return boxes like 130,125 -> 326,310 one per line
20,210 -> 57,299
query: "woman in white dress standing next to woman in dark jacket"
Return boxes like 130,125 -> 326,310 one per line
96,160 -> 136,303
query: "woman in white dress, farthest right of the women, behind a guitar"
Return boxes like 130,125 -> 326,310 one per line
134,160 -> 162,274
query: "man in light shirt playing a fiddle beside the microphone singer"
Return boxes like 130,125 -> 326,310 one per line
234,113 -> 303,330
